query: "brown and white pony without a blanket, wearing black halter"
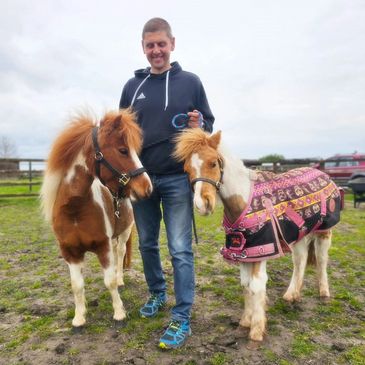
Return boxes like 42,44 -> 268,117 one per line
41,110 -> 152,328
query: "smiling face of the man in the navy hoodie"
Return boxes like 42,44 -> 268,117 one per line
142,31 -> 175,74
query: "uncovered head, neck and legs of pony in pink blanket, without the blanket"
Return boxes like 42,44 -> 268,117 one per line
174,128 -> 338,341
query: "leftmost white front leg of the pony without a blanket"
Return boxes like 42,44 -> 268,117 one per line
67,261 -> 86,327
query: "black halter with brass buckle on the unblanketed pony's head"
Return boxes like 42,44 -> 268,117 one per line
92,127 -> 147,199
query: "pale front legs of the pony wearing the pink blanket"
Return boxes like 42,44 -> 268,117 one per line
240,261 -> 267,341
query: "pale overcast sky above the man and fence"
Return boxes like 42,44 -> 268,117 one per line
0,0 -> 365,159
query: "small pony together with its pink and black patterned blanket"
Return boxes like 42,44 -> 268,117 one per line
174,128 -> 341,341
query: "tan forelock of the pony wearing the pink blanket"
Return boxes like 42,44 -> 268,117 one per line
173,128 -> 210,162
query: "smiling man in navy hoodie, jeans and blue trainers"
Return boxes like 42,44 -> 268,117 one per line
119,18 -> 214,349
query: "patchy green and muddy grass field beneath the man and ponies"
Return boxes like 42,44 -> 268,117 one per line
0,193 -> 365,365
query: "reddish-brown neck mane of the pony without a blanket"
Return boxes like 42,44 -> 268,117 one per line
47,113 -> 95,172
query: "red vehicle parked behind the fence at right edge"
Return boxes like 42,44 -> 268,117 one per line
317,153 -> 365,180
